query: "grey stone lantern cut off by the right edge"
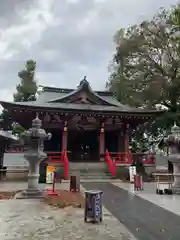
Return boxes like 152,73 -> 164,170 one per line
164,124 -> 180,194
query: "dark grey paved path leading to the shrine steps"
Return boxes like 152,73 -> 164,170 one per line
83,183 -> 180,240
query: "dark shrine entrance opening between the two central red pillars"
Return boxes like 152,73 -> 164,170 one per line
68,131 -> 99,162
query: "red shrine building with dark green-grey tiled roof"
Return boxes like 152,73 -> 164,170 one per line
0,78 -> 162,179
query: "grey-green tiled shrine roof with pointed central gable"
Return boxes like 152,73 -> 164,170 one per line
0,78 -> 165,115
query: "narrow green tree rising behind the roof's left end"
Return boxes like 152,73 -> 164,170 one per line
14,60 -> 37,102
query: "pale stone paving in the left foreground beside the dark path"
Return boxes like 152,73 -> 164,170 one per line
0,199 -> 134,240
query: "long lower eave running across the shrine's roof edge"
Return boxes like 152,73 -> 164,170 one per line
0,101 -> 165,118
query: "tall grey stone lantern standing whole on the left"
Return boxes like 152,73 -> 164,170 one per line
17,116 -> 52,198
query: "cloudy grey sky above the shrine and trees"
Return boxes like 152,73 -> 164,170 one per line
0,0 -> 178,101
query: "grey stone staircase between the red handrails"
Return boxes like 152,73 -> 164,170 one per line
69,162 -> 111,179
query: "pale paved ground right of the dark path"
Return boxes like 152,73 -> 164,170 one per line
112,182 -> 180,216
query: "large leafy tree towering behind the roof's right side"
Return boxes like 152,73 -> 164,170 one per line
107,5 -> 180,129
